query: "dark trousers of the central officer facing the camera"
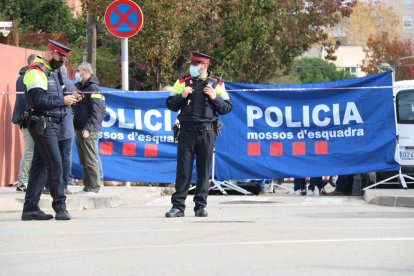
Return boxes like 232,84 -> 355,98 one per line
171,124 -> 216,211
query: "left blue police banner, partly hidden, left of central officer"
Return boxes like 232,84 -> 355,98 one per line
72,89 -> 177,183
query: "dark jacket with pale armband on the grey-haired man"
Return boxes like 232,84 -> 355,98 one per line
72,75 -> 106,132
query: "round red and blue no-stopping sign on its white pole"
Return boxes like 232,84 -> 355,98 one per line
105,0 -> 144,90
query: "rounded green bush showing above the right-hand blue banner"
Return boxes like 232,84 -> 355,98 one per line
294,58 -> 354,83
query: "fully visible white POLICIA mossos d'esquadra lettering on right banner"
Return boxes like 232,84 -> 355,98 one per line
246,102 -> 364,140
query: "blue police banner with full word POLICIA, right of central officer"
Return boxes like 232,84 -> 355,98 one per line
216,73 -> 399,179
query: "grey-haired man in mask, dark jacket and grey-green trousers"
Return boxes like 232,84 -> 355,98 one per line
73,62 -> 106,193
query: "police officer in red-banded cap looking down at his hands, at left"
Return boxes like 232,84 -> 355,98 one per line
22,40 -> 77,220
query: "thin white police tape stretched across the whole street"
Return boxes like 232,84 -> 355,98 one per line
0,84 -> 414,95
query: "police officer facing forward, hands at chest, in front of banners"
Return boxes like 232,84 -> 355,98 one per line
165,52 -> 233,218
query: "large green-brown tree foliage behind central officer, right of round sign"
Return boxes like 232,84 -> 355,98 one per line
126,0 -> 355,89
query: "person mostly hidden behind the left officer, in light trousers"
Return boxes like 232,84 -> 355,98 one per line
12,54 -> 37,192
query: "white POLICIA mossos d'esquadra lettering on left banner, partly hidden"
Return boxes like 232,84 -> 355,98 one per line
99,107 -> 174,144
